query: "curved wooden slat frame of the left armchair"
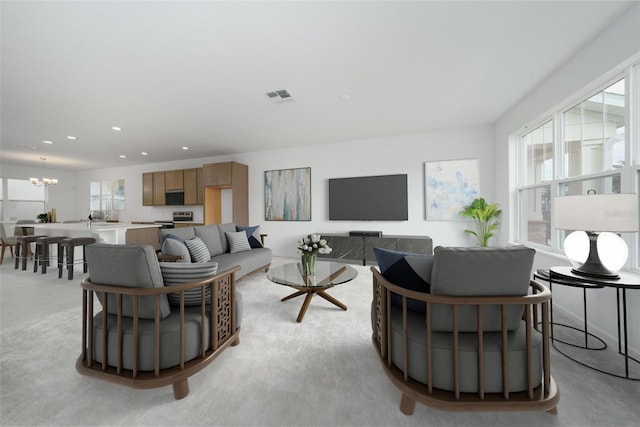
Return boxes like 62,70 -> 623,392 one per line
76,266 -> 240,399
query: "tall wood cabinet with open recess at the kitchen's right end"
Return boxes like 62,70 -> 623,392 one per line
202,162 -> 249,226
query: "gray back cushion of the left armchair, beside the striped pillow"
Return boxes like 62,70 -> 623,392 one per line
85,243 -> 171,319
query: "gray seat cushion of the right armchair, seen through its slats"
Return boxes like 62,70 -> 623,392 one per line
391,307 -> 542,393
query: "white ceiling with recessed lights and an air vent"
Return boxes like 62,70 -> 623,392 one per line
0,0 -> 636,171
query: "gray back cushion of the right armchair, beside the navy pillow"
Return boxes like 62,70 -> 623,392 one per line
431,246 -> 535,332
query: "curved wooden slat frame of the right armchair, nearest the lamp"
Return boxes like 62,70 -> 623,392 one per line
371,267 -> 560,415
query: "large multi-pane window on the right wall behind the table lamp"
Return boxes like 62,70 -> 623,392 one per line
516,64 -> 640,268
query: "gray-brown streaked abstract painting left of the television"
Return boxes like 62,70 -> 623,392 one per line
264,168 -> 311,221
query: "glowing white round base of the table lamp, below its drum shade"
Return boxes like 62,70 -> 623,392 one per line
564,231 -> 629,273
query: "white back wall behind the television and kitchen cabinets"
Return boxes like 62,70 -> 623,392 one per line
65,126 -> 494,256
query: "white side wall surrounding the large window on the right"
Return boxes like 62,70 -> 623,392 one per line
494,4 -> 640,354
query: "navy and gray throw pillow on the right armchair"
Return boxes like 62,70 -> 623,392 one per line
373,248 -> 433,313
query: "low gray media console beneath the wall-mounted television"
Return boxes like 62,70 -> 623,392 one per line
318,232 -> 433,265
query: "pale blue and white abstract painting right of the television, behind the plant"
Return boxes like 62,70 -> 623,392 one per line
424,159 -> 480,221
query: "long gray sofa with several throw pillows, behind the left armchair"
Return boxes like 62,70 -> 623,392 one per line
160,223 -> 272,280
